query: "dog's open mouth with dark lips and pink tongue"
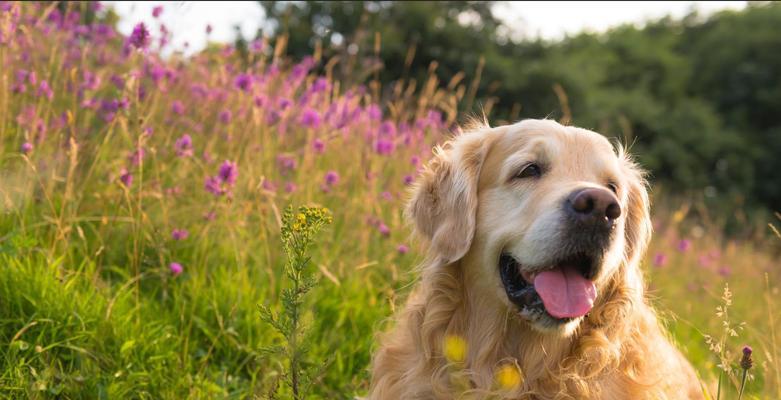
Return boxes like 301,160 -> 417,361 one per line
499,253 -> 597,323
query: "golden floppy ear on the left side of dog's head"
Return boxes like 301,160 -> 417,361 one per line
406,127 -> 489,264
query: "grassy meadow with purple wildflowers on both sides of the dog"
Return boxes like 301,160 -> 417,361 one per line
0,2 -> 781,398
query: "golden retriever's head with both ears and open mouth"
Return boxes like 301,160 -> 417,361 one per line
407,120 -> 650,335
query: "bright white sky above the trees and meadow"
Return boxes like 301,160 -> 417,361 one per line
104,1 -> 746,54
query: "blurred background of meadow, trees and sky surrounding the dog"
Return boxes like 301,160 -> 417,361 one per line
0,2 -> 781,398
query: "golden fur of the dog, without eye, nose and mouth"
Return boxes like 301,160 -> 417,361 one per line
368,120 -> 703,399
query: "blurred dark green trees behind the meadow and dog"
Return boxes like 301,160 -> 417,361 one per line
251,1 -> 781,223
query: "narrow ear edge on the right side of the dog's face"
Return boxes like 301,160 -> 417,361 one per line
619,153 -> 652,265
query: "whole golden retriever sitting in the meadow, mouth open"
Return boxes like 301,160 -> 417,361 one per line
369,120 -> 703,400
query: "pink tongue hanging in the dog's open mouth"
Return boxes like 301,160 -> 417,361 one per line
534,266 -> 597,318
